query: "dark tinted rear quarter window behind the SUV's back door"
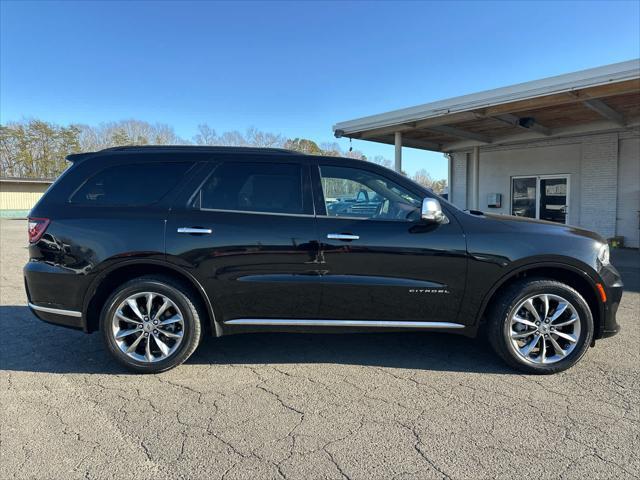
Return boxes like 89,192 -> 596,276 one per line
69,162 -> 191,206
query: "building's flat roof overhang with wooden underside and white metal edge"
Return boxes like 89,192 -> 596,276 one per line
333,59 -> 640,152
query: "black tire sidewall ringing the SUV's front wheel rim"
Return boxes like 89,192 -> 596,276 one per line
500,281 -> 594,373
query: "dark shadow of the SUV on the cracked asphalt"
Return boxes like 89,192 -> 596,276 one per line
0,306 -> 515,374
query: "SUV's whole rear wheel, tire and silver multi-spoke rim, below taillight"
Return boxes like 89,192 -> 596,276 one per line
100,275 -> 202,373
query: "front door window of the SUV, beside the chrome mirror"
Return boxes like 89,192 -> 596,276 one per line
320,166 -> 422,221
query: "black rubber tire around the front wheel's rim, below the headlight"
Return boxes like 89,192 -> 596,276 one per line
487,278 -> 594,375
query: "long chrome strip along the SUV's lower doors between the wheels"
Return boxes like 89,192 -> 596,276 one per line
224,318 -> 465,329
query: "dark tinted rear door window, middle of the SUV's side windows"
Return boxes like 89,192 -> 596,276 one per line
199,162 -> 304,213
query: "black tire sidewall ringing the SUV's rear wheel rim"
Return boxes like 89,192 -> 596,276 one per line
100,280 -> 200,373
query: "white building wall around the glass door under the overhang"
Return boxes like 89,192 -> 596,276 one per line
451,128 -> 640,248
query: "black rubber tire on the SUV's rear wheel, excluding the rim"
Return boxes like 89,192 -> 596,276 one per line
100,275 -> 204,373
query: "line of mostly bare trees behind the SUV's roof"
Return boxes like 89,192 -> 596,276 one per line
0,119 -> 446,193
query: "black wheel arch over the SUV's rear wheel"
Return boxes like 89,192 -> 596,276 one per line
82,259 -> 222,336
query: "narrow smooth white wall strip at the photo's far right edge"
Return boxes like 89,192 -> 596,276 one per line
617,135 -> 640,248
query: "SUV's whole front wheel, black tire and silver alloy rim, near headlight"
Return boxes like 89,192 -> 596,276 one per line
488,279 -> 593,374
